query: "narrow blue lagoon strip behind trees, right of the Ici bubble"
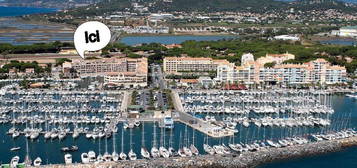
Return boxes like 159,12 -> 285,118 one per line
120,35 -> 238,45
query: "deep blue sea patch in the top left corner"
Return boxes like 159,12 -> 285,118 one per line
0,6 -> 57,17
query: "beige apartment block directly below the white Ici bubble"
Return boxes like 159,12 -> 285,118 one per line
62,57 -> 148,88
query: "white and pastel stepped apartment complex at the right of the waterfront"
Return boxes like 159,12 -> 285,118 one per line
215,55 -> 346,84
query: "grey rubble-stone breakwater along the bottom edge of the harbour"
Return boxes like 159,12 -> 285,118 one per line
28,137 -> 357,168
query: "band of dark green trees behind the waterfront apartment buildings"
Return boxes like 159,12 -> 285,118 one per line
0,38 -> 357,74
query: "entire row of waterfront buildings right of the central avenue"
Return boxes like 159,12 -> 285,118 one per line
164,53 -> 347,84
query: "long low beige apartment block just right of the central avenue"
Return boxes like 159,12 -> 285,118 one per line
163,57 -> 234,74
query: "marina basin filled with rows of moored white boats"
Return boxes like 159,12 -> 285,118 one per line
0,85 -> 356,167
